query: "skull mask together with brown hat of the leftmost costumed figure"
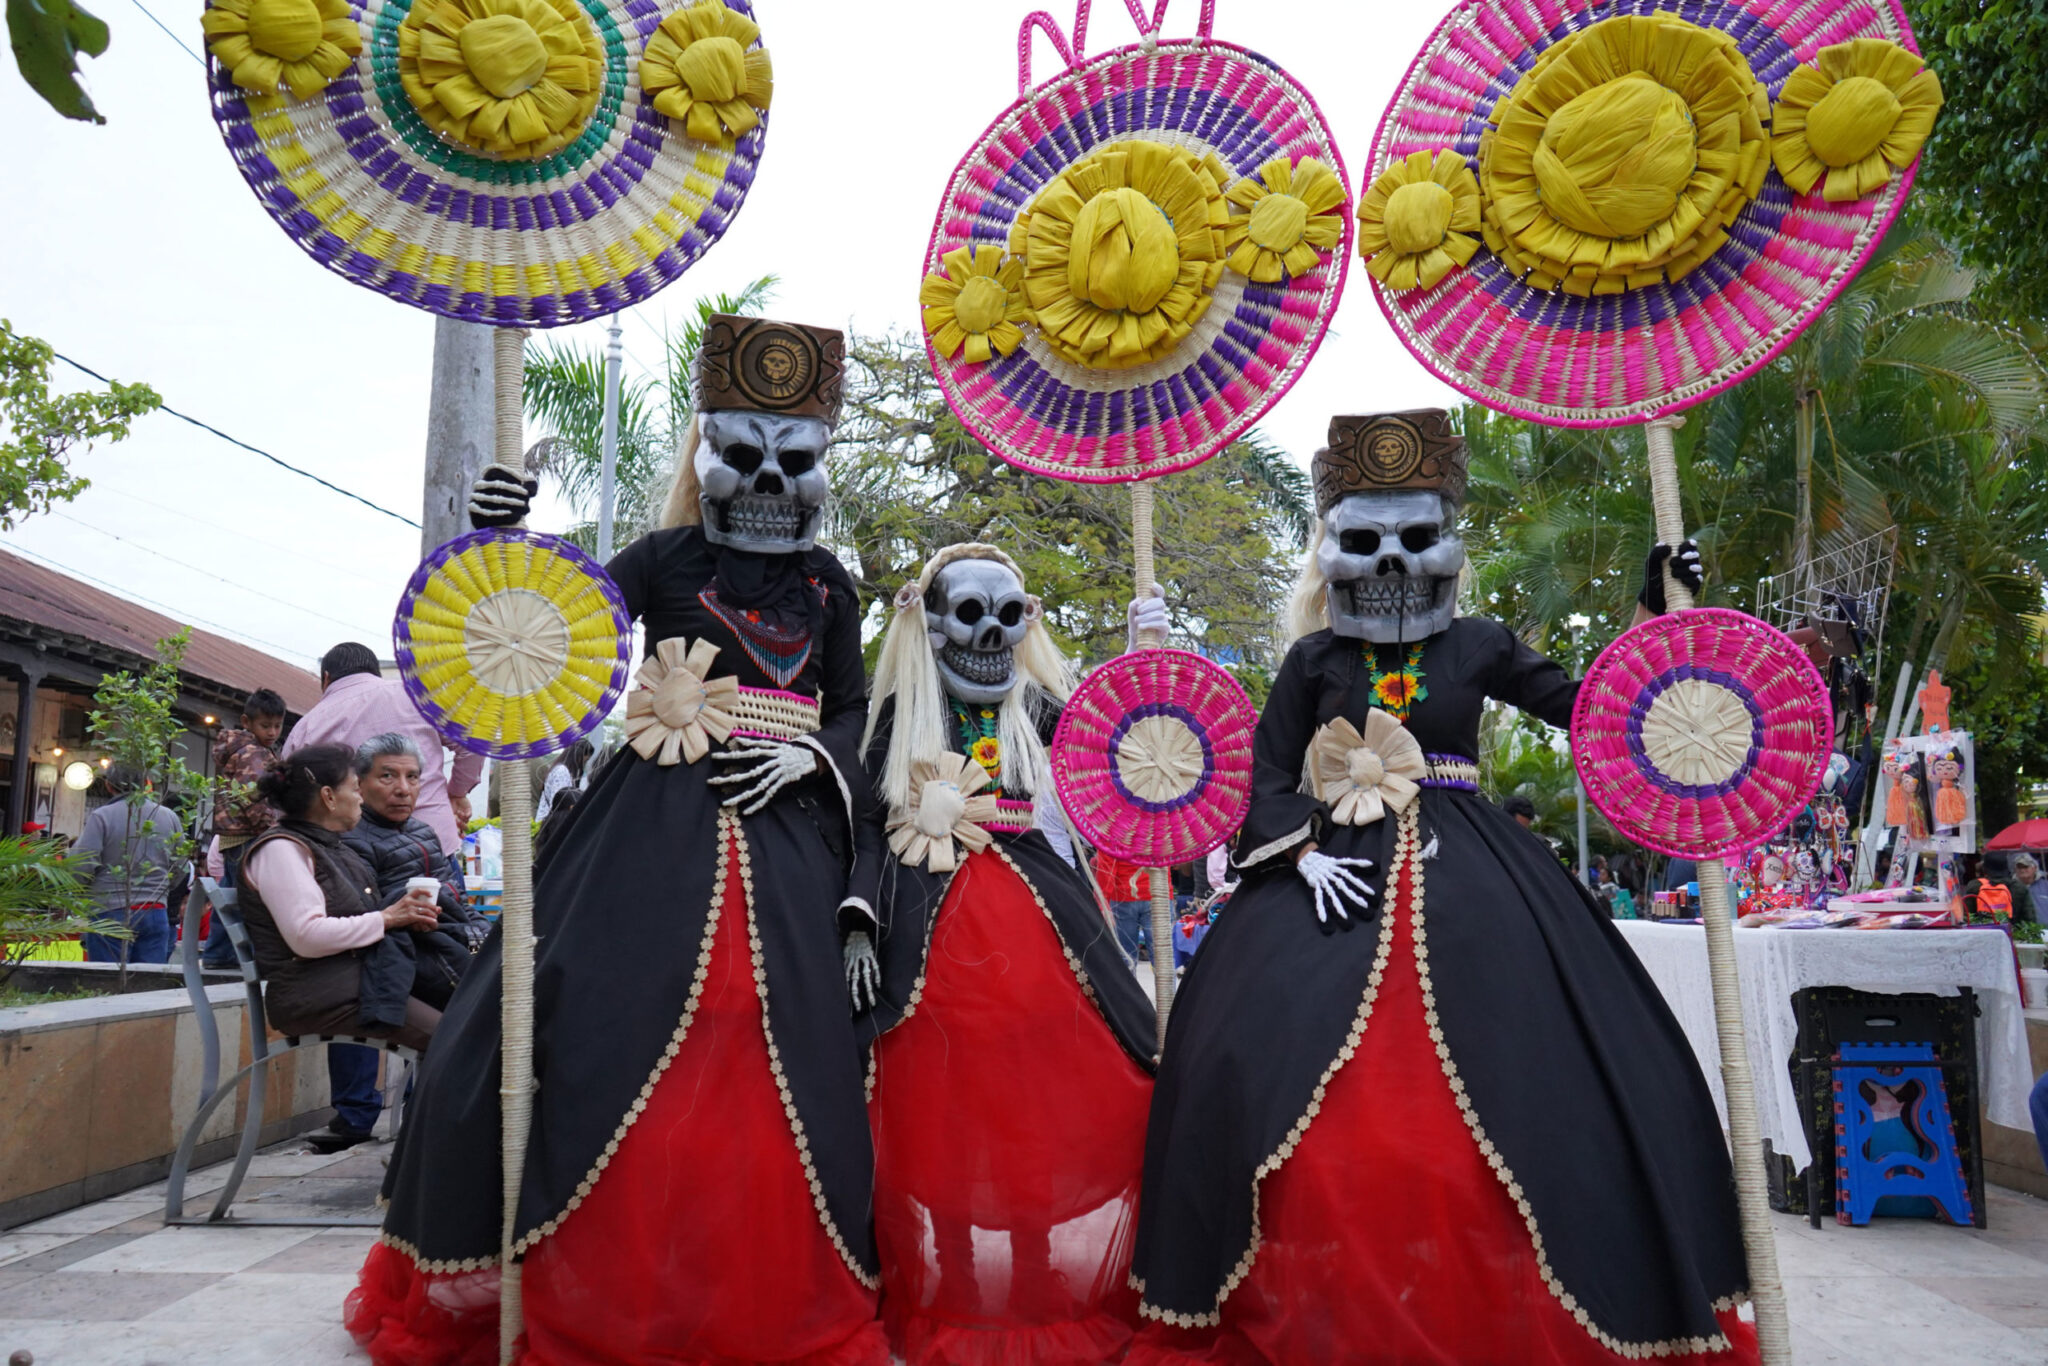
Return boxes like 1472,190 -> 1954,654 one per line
690,313 -> 846,555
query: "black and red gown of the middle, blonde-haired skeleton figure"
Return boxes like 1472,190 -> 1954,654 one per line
854,700 -> 1157,1366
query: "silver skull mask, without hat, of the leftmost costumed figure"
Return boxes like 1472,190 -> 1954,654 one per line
696,410 -> 831,555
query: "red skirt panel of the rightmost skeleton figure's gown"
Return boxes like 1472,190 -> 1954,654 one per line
1126,847 -> 1757,1366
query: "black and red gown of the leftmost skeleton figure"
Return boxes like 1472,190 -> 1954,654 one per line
346,526 -> 889,1366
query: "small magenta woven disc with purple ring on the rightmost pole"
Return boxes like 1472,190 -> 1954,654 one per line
1571,608 -> 1835,858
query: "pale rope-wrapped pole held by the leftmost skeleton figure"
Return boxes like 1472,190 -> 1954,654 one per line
494,328 -> 532,1366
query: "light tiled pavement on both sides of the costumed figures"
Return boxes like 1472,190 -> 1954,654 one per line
0,1143 -> 2048,1366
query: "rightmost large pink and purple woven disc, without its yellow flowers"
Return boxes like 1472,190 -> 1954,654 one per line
1366,0 -> 1913,426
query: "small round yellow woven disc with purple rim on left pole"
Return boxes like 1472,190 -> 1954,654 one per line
391,528 -> 633,760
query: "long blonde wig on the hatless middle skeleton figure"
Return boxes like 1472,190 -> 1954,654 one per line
860,541 -> 1073,811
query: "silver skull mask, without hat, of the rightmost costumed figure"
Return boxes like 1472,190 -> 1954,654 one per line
1317,489 -> 1464,643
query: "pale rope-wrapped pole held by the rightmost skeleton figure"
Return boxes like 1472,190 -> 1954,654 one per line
1642,418 -> 1785,1366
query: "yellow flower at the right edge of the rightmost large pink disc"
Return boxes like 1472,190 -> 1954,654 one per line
1772,39 -> 1942,203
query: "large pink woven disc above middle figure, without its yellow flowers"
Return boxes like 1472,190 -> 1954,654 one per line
926,39 -> 1356,483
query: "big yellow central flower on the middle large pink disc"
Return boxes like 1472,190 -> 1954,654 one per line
1010,137 -> 1231,371
